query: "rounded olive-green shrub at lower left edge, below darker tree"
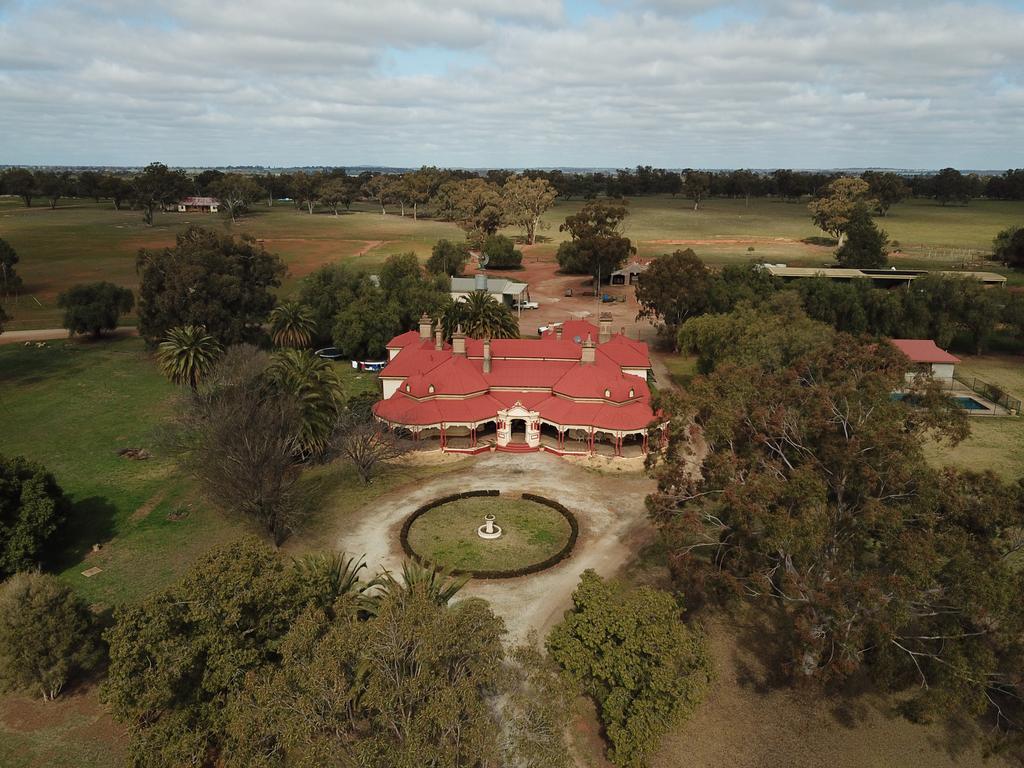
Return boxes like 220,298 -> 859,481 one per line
0,572 -> 100,700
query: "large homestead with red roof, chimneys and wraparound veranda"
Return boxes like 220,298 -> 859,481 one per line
374,314 -> 655,457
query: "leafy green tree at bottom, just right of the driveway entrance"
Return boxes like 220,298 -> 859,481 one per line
547,569 -> 711,768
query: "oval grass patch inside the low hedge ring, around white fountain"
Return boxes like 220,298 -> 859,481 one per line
409,497 -> 570,570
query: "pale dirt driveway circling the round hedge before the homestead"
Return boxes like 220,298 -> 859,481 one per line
337,454 -> 653,642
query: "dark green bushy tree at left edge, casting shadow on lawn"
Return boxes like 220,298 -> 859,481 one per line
0,456 -> 70,579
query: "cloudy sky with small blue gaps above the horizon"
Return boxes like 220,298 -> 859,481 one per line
0,0 -> 1024,169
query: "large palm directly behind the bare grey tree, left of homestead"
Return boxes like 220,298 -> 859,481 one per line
267,349 -> 345,459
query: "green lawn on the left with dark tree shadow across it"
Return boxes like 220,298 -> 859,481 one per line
0,339 -> 245,604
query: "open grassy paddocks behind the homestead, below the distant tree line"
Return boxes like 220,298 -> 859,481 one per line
0,197 -> 1024,329
